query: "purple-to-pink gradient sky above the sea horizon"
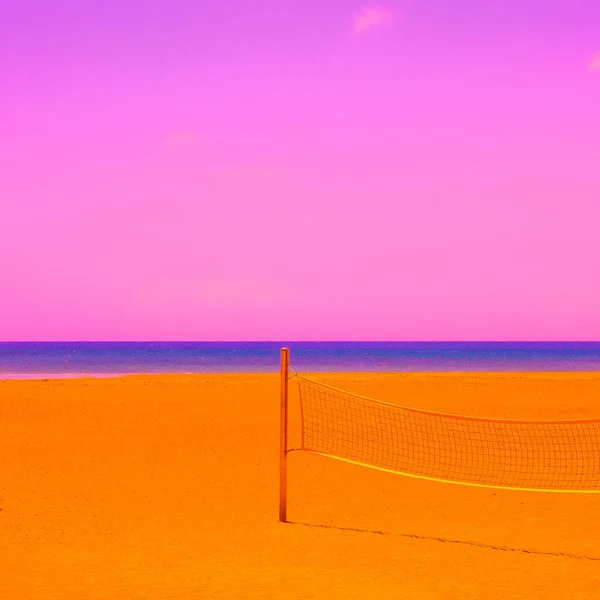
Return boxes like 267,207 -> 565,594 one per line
0,0 -> 600,340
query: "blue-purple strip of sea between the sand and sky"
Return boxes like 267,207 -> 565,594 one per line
0,342 -> 600,379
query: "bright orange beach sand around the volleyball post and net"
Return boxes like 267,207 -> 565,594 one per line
0,373 -> 600,600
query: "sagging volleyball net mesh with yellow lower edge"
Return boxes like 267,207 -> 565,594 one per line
298,376 -> 600,492
